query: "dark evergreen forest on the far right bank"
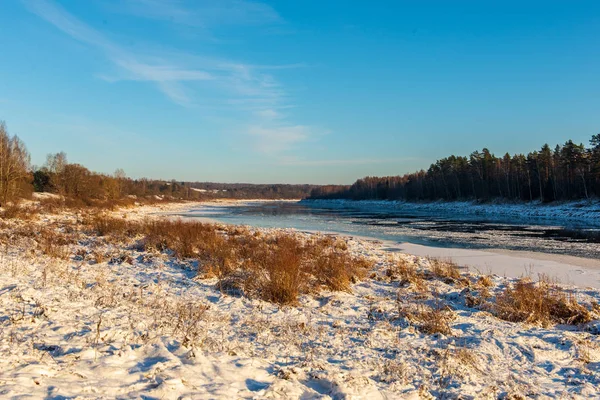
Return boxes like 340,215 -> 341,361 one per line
310,134 -> 600,202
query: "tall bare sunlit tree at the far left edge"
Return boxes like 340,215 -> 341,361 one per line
0,121 -> 30,204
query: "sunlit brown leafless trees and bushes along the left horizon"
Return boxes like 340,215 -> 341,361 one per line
0,121 -> 316,206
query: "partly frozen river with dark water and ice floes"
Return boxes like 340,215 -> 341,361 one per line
177,202 -> 600,259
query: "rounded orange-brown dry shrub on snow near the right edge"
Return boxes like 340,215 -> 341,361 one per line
494,276 -> 592,326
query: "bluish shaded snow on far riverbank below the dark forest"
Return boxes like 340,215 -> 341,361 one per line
303,200 -> 600,225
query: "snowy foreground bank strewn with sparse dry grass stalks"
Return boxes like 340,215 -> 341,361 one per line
0,206 -> 600,399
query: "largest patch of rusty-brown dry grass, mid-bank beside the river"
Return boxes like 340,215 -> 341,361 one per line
87,215 -> 372,304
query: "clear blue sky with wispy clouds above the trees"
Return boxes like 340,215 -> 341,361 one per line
0,0 -> 600,183
